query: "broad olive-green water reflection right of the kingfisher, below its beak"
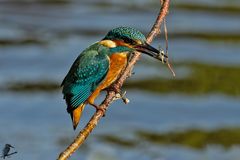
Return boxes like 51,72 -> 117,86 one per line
125,63 -> 240,96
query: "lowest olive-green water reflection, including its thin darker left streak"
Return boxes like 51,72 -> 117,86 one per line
97,128 -> 240,149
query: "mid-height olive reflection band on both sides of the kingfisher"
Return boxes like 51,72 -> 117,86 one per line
3,63 -> 240,96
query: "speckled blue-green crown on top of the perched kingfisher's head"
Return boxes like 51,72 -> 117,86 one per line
104,27 -> 146,42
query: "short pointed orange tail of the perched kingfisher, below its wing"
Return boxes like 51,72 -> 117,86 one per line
70,103 -> 86,130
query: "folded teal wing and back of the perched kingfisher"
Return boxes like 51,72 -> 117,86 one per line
62,44 -> 109,112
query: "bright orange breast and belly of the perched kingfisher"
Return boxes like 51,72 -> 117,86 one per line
87,53 -> 127,104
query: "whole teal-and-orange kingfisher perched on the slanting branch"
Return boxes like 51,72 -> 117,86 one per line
61,27 -> 167,130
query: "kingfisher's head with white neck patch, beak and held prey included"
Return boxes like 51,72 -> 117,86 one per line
100,27 -> 166,62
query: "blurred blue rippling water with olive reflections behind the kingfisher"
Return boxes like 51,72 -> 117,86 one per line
0,0 -> 240,160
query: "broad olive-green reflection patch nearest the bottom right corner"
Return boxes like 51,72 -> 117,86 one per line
136,128 -> 240,149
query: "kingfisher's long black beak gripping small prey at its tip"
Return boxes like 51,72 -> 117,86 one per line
135,43 -> 167,63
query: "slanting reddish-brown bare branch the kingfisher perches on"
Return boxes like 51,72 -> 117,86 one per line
58,0 -> 170,160
